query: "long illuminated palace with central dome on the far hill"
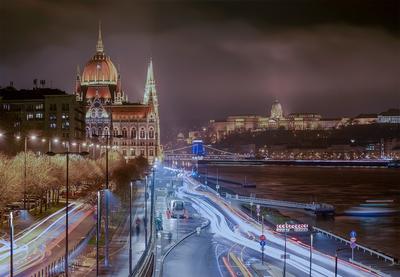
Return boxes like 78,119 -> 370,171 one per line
205,100 -> 400,142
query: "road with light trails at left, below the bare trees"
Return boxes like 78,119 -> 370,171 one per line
0,203 -> 94,276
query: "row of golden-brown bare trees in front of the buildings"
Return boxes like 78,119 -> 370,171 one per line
0,152 -> 147,221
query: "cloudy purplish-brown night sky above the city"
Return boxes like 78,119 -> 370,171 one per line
0,0 -> 400,138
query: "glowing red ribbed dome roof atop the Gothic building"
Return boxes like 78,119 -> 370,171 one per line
82,52 -> 118,85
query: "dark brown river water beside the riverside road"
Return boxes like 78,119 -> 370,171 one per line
200,166 -> 400,257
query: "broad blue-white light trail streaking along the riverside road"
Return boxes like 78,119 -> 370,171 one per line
178,177 -> 376,276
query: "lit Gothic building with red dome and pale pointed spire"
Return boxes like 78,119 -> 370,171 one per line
75,26 -> 160,162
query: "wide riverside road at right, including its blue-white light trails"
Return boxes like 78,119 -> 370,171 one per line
158,166 -> 376,276
